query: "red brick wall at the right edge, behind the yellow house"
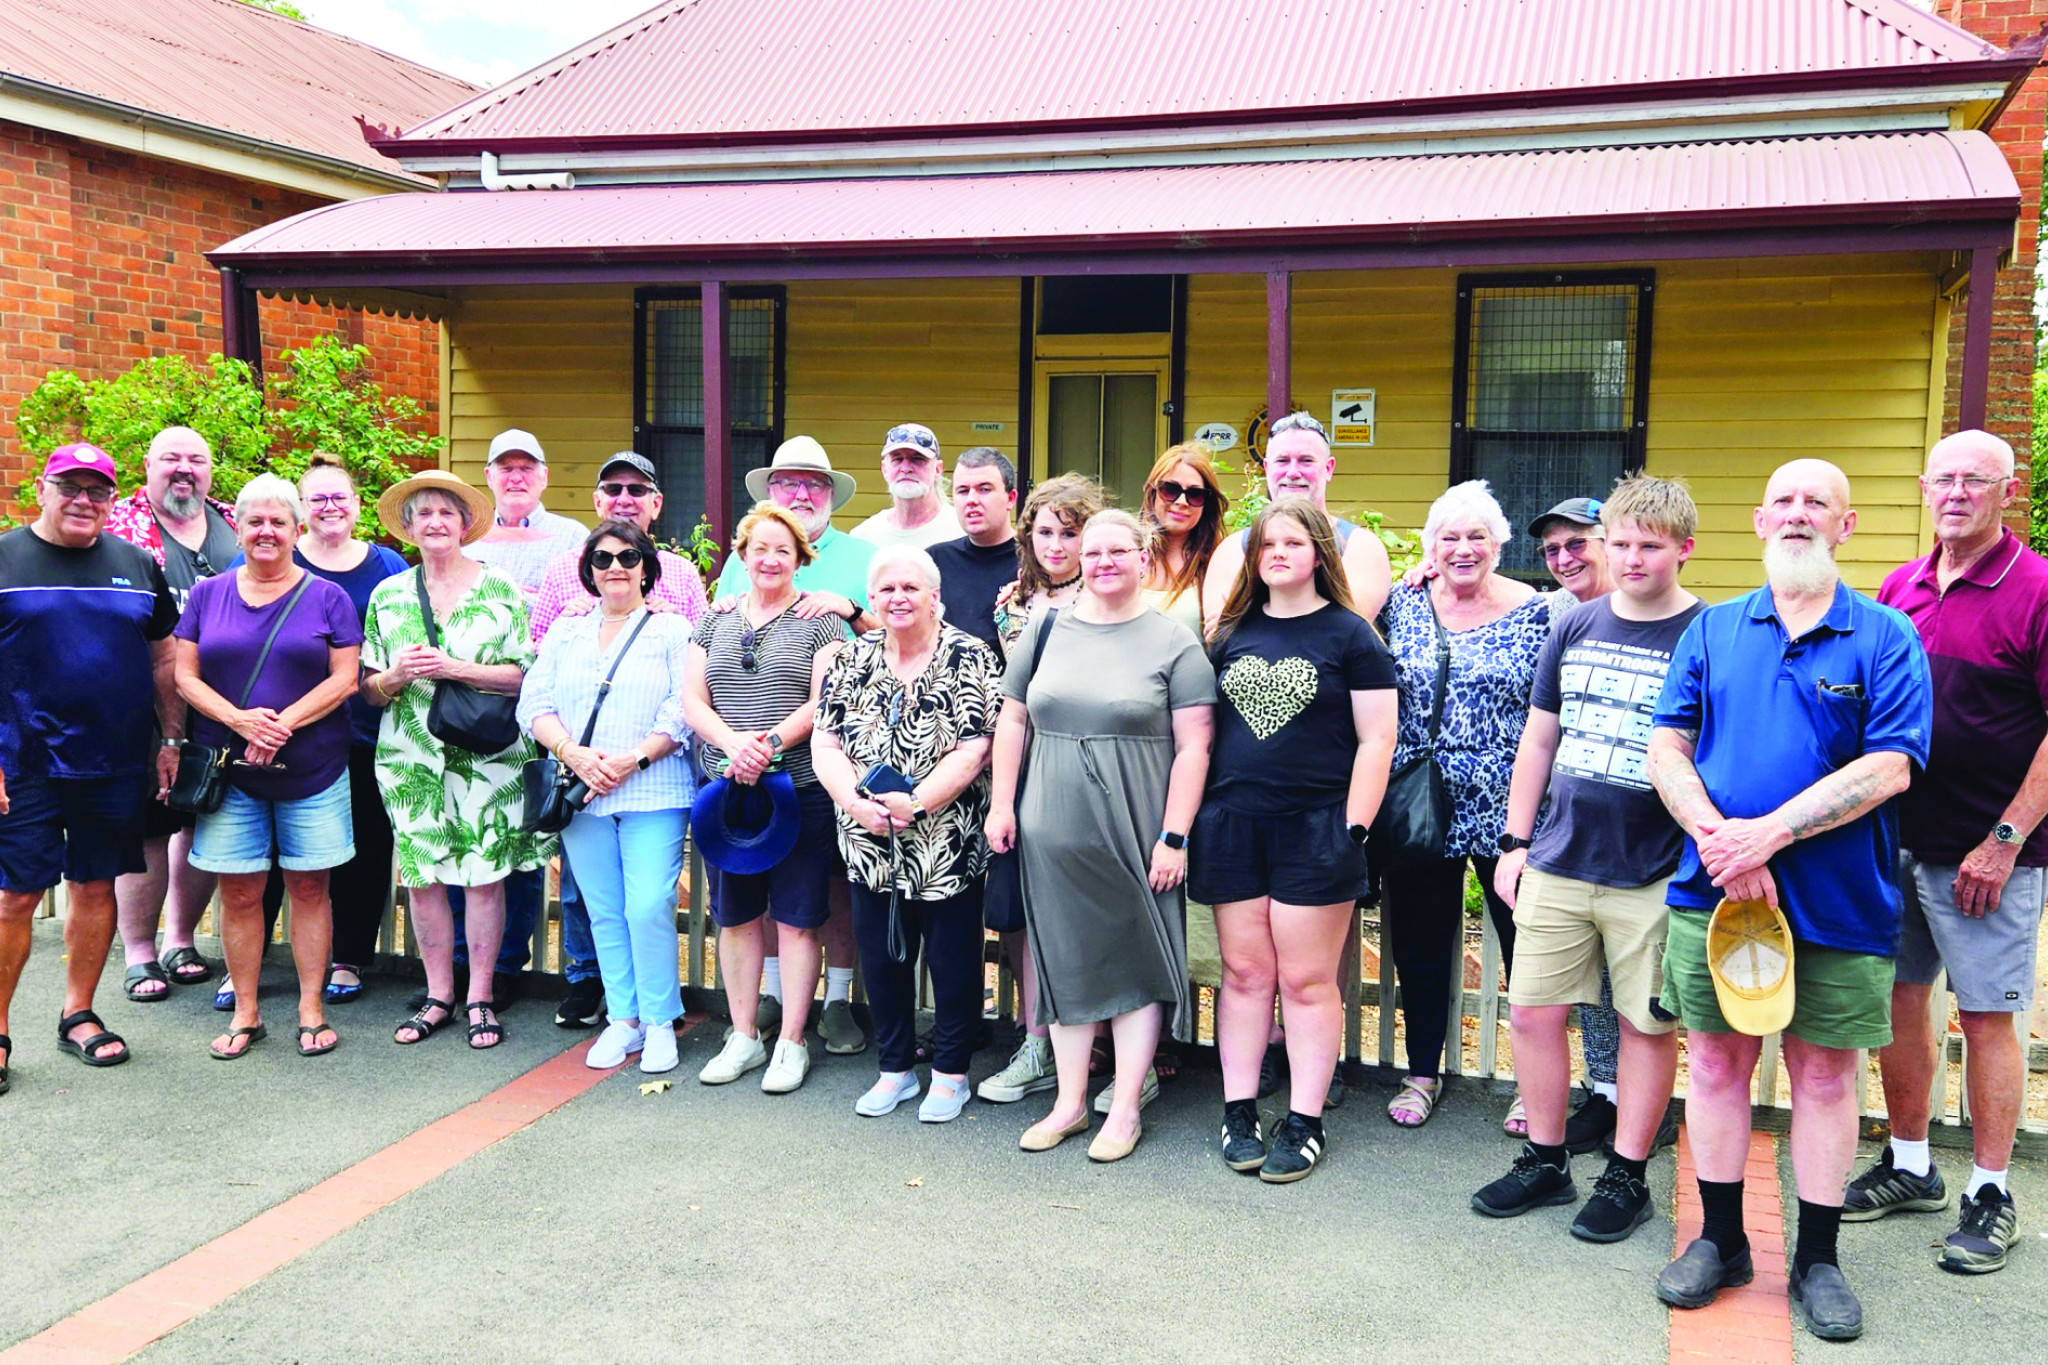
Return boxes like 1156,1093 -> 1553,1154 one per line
1933,0 -> 2048,532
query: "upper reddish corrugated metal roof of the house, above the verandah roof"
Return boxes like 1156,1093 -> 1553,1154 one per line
397,0 -> 1999,149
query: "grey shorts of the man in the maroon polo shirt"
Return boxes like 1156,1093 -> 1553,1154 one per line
1898,853 -> 2048,1015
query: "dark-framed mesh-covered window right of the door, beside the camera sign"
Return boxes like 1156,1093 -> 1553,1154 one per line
1450,270 -> 1655,585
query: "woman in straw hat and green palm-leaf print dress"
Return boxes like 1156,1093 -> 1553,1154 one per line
362,469 -> 553,1048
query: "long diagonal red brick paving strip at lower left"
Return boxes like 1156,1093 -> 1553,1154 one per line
0,1021 -> 694,1365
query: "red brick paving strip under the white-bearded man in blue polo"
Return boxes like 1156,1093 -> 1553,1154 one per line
1662,1128 -> 1792,1365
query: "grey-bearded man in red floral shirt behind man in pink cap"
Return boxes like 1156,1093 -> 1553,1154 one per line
106,426 -> 242,1003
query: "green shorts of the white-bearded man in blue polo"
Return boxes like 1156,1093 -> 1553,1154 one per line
1659,907 -> 1892,1050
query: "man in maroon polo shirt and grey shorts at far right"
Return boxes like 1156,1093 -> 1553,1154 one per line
1843,432 -> 2048,1273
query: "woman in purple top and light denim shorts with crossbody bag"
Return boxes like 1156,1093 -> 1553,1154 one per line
176,475 -> 362,1062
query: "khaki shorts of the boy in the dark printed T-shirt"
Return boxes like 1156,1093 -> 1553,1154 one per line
1507,868 -> 1677,1033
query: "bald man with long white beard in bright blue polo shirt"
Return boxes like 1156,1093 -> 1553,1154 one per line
1649,460 -> 1933,1340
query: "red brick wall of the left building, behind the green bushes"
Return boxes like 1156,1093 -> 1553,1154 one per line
0,123 -> 440,512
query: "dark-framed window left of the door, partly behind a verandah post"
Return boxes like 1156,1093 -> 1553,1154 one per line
633,287 -> 784,542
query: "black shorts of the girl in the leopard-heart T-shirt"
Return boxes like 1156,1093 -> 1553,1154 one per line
1188,800 -> 1366,905
